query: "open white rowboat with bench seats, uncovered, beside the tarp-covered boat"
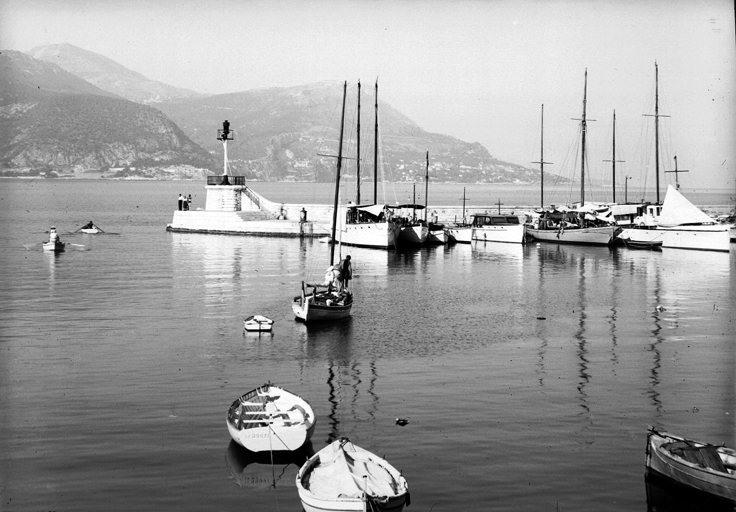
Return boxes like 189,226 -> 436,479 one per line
226,383 -> 316,452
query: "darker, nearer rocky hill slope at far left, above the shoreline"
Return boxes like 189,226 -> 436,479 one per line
0,51 -> 217,178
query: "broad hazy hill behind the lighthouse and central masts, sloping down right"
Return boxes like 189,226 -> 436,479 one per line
158,82 -> 539,183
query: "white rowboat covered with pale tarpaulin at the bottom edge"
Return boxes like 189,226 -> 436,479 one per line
296,437 -> 410,512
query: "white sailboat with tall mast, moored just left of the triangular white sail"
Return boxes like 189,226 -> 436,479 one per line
527,69 -> 620,245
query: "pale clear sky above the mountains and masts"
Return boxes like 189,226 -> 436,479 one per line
0,0 -> 736,195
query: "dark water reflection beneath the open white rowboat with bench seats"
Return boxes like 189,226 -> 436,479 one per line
225,440 -> 315,489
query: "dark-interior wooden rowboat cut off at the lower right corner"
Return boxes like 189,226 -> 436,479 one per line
646,426 -> 736,504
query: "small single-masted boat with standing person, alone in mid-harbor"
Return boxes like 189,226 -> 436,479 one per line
291,82 -> 353,322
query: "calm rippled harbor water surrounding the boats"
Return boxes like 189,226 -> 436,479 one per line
0,180 -> 736,512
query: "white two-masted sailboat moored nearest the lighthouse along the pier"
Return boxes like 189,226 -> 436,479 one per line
340,81 -> 400,249
